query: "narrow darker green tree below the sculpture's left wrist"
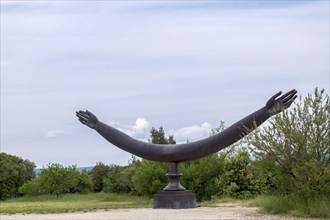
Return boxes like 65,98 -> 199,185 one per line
89,162 -> 111,192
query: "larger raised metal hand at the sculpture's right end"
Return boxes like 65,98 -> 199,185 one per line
266,89 -> 297,115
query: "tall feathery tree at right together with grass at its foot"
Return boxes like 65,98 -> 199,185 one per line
248,88 -> 330,218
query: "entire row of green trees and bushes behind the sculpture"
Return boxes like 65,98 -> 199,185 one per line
0,88 -> 330,201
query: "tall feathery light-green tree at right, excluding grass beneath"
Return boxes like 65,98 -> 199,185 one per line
248,88 -> 330,195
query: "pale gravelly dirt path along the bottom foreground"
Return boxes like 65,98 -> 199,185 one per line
0,203 -> 318,220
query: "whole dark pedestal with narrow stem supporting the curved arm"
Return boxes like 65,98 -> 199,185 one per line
154,163 -> 196,209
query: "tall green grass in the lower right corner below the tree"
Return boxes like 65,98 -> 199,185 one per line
251,194 -> 330,218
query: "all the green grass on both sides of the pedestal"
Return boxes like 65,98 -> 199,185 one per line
0,193 -> 330,218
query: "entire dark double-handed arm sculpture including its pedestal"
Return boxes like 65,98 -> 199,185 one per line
76,90 -> 297,208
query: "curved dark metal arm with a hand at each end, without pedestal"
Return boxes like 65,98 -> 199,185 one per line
76,90 -> 297,163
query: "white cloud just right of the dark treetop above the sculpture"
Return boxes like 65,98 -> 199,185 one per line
170,122 -> 212,143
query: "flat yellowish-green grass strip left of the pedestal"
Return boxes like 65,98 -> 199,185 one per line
0,193 -> 153,214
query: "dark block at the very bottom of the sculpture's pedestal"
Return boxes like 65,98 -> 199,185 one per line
154,190 -> 196,209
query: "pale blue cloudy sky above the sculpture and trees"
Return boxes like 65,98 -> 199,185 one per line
0,0 -> 330,167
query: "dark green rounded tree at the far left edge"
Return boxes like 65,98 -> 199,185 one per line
0,153 -> 35,200
